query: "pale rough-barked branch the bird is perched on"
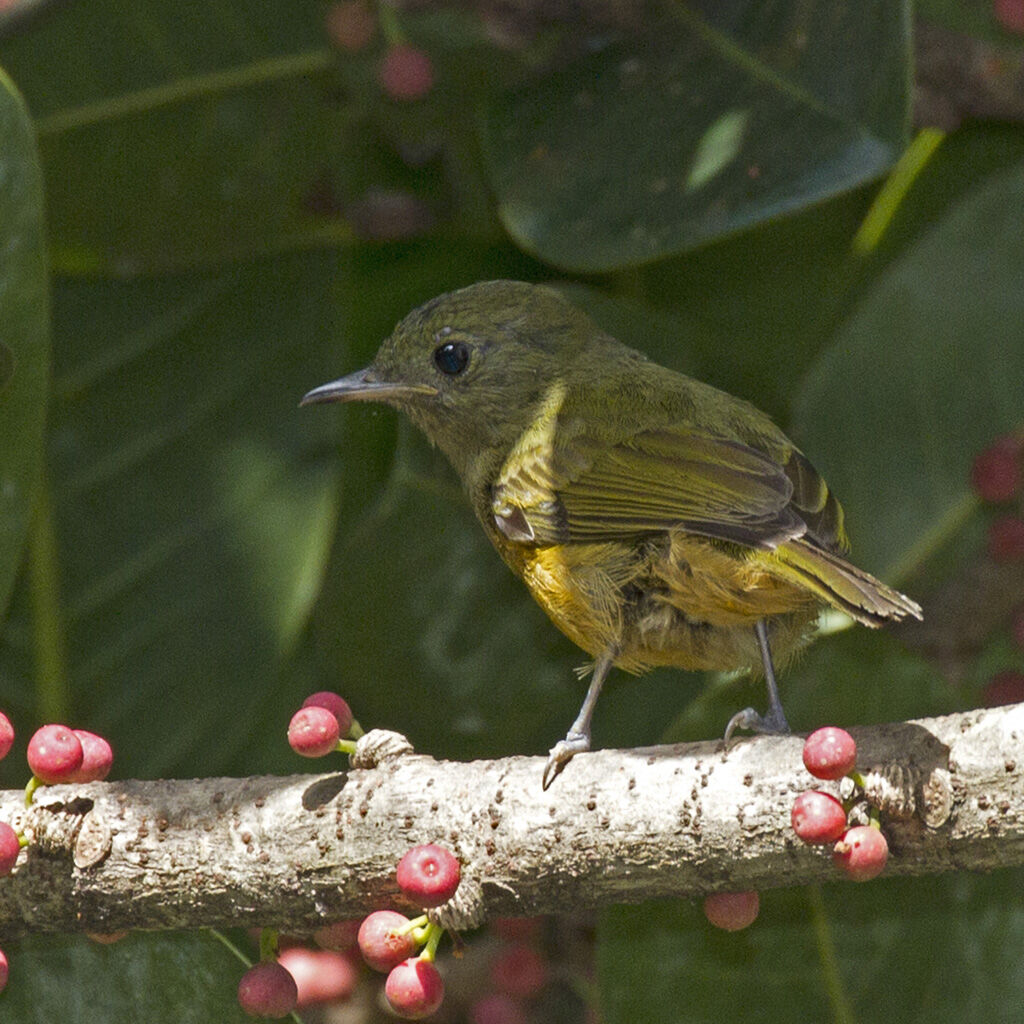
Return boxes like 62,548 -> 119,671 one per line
0,705 -> 1024,940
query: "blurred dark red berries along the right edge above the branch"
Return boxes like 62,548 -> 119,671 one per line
971,432 -> 1024,708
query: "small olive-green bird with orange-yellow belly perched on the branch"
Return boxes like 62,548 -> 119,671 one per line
302,281 -> 921,788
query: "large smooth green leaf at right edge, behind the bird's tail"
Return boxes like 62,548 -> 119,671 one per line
794,166 -> 1024,582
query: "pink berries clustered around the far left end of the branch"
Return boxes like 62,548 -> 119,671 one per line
0,712 -> 114,992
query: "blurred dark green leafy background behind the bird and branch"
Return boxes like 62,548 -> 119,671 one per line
0,0 -> 1024,1024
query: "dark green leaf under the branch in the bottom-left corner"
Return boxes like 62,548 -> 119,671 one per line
0,933 -> 251,1024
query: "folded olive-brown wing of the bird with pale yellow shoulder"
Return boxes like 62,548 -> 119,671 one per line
493,427 -> 843,548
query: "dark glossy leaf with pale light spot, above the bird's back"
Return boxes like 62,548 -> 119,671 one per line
482,2 -> 907,273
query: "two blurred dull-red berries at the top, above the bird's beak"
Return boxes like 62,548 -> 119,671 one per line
325,0 -> 434,101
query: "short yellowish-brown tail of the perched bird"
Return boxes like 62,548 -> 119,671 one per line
772,538 -> 921,628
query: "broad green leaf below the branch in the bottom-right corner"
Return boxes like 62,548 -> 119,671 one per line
598,872 -> 1024,1024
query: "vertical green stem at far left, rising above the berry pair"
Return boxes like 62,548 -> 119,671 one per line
28,474 -> 71,722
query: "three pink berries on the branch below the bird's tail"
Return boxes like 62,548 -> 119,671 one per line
791,725 -> 889,882
